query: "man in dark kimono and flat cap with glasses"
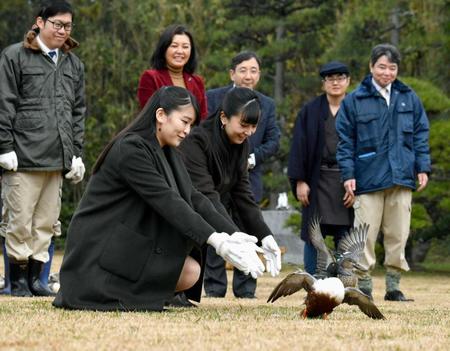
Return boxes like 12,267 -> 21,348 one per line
288,61 -> 353,274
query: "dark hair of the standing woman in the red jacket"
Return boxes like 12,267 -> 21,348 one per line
150,24 -> 197,74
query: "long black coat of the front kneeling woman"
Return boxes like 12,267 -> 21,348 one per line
54,134 -> 235,311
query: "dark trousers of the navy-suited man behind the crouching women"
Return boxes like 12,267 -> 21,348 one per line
203,245 -> 256,298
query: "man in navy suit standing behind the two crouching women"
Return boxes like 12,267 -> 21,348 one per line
204,51 -> 281,298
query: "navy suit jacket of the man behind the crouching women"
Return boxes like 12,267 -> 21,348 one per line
206,85 -> 281,202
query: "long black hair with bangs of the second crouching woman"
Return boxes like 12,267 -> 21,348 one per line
200,87 -> 261,179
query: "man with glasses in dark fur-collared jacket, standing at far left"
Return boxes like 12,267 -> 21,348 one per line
0,1 -> 86,296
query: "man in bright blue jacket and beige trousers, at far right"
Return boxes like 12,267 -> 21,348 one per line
336,44 -> 431,301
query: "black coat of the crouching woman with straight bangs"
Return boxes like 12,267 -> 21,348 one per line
179,124 -> 272,240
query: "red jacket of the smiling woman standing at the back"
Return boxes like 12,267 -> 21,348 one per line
137,69 -> 208,119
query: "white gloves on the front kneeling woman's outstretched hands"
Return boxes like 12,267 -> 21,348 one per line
207,232 -> 264,279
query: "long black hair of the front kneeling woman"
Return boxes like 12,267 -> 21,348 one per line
92,86 -> 200,174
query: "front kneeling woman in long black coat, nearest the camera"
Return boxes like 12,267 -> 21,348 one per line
53,87 -> 264,311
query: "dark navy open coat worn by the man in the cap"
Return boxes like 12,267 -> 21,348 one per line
288,94 -> 330,240
